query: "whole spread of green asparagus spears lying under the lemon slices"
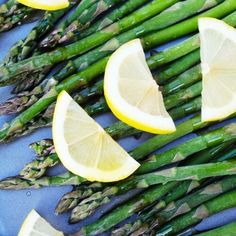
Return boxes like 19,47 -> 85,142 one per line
0,0 -> 236,235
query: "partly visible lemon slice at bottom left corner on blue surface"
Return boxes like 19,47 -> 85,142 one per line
18,210 -> 64,236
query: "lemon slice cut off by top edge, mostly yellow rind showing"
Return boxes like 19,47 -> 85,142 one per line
17,0 -> 69,11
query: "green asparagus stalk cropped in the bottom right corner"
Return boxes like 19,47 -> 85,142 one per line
198,222 -> 236,236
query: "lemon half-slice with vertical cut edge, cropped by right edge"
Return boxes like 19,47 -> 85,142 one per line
198,18 -> 236,121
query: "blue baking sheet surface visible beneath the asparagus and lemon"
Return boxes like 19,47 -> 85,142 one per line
0,0 -> 236,236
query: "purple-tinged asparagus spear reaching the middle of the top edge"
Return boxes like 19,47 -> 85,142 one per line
57,0 -> 125,44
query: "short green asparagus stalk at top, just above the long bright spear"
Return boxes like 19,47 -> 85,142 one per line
76,0 -> 147,40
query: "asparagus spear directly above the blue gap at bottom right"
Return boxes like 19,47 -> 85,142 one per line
156,190 -> 236,236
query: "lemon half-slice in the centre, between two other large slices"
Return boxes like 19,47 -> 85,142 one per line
104,39 -> 175,134
